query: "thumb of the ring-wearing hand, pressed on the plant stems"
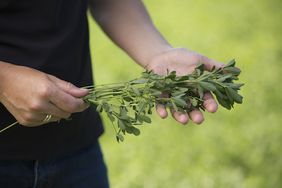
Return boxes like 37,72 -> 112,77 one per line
48,75 -> 89,98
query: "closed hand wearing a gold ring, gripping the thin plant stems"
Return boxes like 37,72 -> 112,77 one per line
0,62 -> 88,127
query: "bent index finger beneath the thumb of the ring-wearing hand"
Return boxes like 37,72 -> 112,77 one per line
50,88 -> 89,113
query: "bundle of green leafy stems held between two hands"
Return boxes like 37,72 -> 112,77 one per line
84,60 -> 243,141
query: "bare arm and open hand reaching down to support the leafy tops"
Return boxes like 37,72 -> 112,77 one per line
90,0 -> 223,124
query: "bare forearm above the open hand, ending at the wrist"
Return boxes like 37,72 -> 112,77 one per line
90,0 -> 170,67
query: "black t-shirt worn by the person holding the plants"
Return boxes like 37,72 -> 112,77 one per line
0,0 -> 103,160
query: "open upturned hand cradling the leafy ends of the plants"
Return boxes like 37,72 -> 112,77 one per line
146,48 -> 224,124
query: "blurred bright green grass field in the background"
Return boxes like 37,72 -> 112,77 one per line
90,0 -> 282,188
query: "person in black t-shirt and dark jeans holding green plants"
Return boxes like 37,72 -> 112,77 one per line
0,0 -> 223,188
